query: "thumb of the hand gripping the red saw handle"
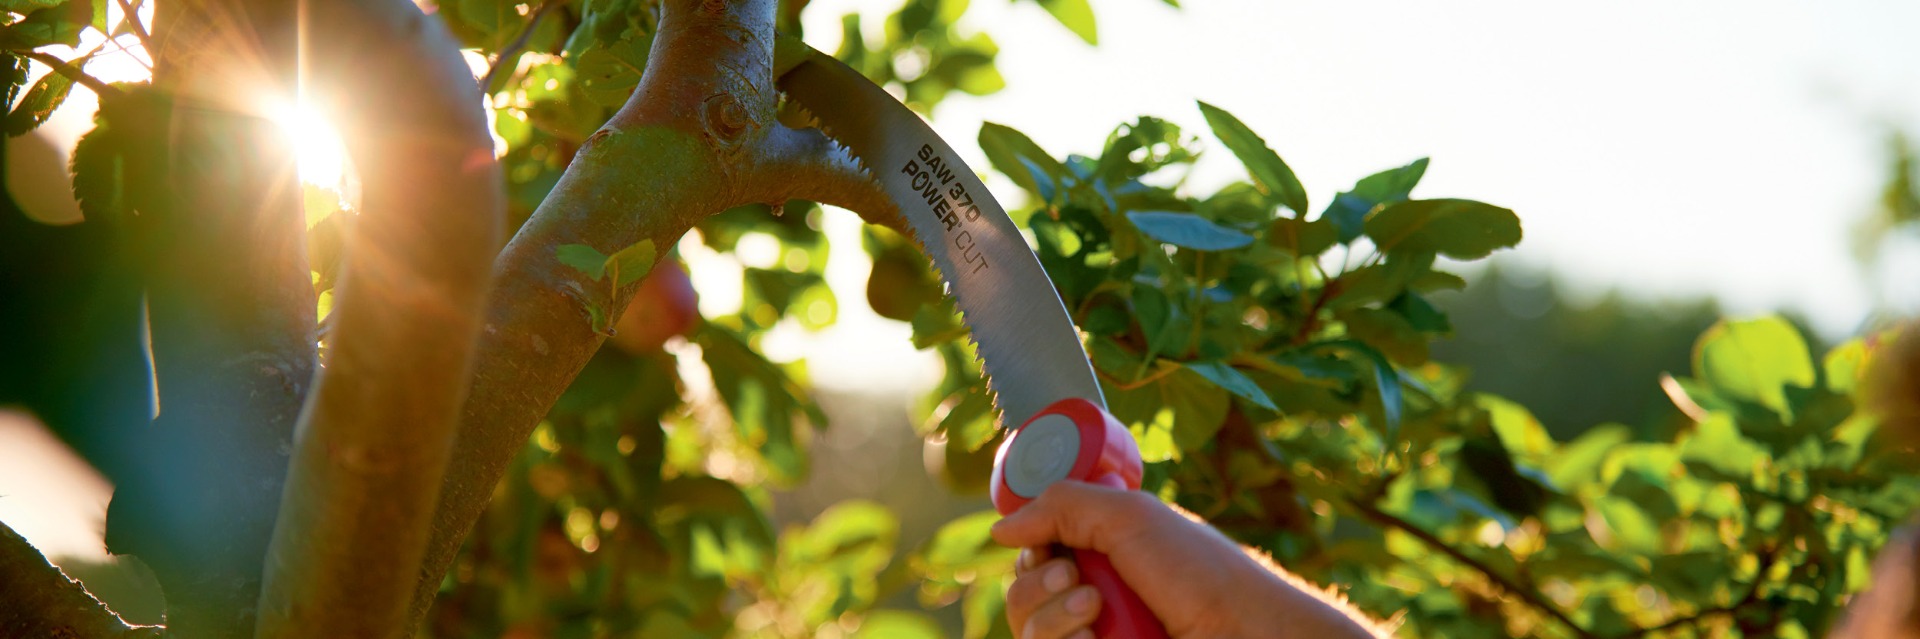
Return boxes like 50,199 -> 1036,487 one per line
993,480 -> 1173,553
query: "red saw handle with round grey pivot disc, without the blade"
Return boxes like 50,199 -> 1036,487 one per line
991,397 -> 1167,639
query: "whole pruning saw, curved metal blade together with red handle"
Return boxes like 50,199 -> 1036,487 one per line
780,42 -> 1165,639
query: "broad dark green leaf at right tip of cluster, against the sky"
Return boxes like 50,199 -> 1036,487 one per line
1367,200 -> 1521,259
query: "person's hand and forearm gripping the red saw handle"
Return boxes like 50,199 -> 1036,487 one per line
993,482 -> 1373,639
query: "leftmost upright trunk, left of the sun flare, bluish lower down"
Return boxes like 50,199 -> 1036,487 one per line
108,0 -> 315,637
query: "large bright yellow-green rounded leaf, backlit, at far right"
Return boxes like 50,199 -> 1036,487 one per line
1693,317 -> 1814,420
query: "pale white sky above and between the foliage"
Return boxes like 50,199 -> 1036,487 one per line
11,0 -> 1920,555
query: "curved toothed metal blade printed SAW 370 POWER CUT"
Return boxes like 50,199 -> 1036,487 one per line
780,52 -> 1106,428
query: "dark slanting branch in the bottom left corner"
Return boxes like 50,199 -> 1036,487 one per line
0,522 -> 161,639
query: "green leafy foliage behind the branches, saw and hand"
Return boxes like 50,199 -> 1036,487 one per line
11,0 -> 1920,637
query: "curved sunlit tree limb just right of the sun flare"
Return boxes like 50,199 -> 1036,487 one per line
255,0 -> 505,637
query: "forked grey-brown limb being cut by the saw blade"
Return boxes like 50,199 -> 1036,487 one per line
413,0 -> 897,620
